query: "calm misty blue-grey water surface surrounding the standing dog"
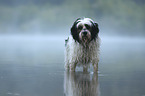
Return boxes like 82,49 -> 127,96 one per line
0,35 -> 145,96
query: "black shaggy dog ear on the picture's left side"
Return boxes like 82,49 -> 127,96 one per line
71,18 -> 81,42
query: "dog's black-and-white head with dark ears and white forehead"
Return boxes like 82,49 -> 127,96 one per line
71,18 -> 99,43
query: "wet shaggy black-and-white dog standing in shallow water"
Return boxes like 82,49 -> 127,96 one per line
65,18 -> 100,72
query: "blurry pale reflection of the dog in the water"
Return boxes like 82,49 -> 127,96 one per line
64,71 -> 100,96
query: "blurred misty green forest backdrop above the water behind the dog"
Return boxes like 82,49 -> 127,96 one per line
0,0 -> 145,36
